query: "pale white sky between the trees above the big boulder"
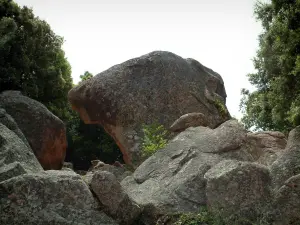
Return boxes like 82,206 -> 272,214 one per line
16,0 -> 262,118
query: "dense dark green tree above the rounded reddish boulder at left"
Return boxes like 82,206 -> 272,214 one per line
0,0 -> 72,119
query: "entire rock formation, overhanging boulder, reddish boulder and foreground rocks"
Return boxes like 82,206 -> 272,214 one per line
0,52 -> 300,225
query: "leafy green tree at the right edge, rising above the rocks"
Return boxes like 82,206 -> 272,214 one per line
240,0 -> 300,131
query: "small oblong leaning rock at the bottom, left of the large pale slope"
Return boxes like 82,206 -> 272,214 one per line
91,171 -> 140,224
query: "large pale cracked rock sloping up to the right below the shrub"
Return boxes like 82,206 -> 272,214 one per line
121,120 -> 247,218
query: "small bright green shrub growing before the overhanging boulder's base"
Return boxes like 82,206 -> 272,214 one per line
142,123 -> 168,158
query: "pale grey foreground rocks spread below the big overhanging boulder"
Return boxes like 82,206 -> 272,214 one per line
0,101 -> 300,225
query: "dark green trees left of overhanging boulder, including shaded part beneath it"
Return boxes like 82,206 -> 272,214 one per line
0,0 -> 122,169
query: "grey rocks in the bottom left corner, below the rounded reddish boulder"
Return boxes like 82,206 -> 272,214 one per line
0,108 -> 118,225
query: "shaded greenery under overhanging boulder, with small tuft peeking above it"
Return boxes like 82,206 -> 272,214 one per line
66,71 -> 123,170
